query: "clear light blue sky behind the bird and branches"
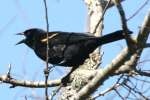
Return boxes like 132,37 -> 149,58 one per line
0,0 -> 150,100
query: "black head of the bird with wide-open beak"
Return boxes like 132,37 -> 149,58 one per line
16,28 -> 46,47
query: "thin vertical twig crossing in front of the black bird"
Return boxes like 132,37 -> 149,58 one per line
44,0 -> 49,100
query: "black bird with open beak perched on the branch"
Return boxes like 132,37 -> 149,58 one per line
17,28 -> 132,84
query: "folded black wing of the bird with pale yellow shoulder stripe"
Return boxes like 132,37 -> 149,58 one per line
41,32 -> 96,45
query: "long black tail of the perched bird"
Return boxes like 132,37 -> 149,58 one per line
97,30 -> 132,45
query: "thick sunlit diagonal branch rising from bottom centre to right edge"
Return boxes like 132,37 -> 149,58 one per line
73,12 -> 150,100
